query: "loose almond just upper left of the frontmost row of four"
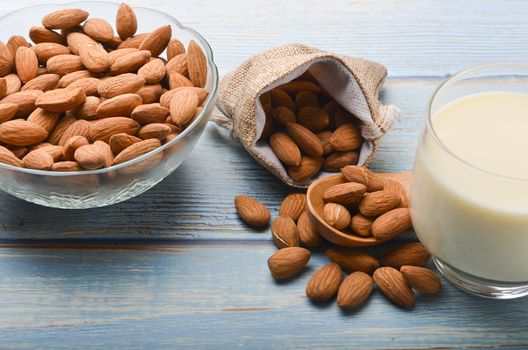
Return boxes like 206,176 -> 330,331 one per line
268,247 -> 311,280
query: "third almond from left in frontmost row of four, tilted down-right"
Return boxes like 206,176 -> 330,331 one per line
374,267 -> 414,308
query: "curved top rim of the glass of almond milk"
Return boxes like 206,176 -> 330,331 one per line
426,62 -> 528,182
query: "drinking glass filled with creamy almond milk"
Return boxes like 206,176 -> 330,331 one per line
411,64 -> 528,299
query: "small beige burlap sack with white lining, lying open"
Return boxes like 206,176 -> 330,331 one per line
213,44 -> 398,188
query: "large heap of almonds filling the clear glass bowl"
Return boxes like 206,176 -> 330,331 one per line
0,4 -> 208,171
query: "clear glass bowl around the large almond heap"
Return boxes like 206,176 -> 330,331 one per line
0,1 -> 218,209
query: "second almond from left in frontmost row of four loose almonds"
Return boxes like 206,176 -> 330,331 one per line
337,271 -> 374,309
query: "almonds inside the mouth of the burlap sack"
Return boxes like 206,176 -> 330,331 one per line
260,71 -> 363,183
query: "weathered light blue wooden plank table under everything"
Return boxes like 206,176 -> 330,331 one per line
0,0 -> 528,349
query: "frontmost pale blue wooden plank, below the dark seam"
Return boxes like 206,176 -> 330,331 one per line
0,242 -> 528,349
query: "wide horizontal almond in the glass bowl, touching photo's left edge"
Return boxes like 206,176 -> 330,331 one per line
0,119 -> 48,147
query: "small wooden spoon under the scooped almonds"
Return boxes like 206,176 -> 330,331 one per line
306,172 -> 411,247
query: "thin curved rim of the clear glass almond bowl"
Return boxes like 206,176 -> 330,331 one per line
0,1 -> 219,177
